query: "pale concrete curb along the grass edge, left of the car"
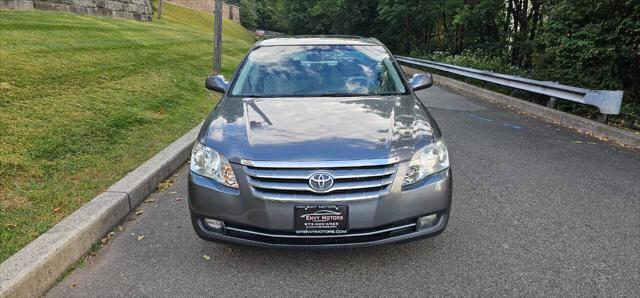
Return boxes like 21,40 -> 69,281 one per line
0,124 -> 202,297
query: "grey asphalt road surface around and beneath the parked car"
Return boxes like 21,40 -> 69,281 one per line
48,87 -> 640,297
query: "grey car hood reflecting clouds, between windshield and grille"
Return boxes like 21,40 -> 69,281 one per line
199,95 -> 440,163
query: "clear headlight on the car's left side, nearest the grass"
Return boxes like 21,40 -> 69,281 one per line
191,141 -> 238,188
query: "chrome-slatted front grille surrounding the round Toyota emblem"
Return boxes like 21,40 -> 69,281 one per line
244,163 -> 398,201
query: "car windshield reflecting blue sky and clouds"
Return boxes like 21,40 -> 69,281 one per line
230,45 -> 406,97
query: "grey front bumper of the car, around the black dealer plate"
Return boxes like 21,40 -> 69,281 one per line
189,164 -> 452,249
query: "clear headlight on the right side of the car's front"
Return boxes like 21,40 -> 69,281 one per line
402,139 -> 449,185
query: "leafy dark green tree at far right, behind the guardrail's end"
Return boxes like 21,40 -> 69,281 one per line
533,0 -> 640,126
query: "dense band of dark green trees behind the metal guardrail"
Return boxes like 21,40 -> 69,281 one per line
252,0 -> 640,126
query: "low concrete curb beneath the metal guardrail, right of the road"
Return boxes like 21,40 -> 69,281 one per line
402,66 -> 640,149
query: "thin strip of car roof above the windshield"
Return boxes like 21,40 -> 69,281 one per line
256,35 -> 382,47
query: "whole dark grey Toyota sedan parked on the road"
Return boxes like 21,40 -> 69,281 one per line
189,36 -> 452,248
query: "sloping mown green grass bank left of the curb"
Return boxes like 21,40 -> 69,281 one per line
0,2 -> 254,261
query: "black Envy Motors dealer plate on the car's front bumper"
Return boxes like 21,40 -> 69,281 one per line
293,205 -> 349,234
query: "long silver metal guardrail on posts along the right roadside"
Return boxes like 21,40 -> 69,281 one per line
395,56 -> 624,123
